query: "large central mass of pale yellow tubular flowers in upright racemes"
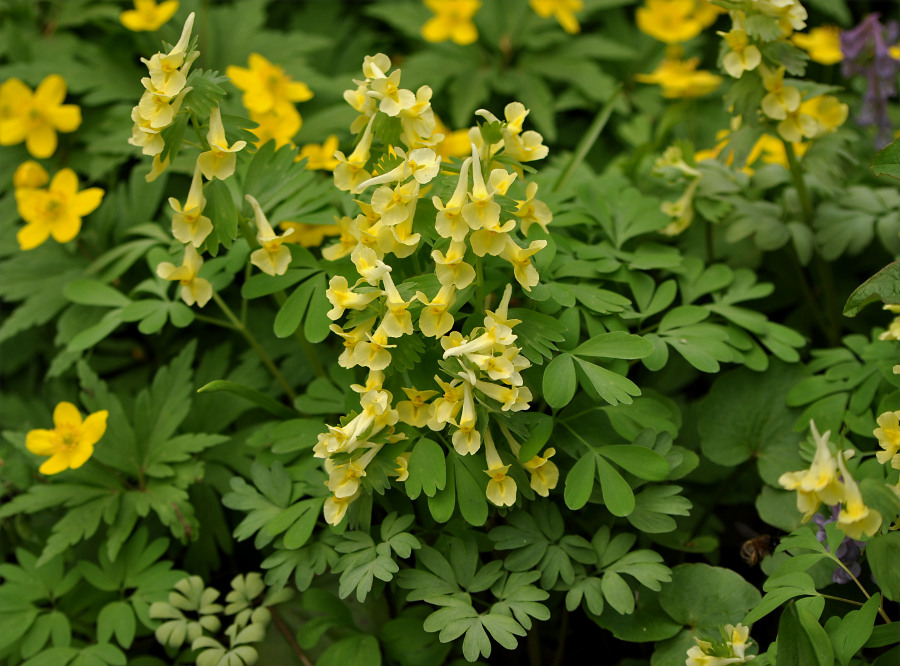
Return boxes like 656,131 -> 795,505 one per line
314,54 -> 558,524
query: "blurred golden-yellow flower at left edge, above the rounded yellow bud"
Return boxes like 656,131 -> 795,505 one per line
0,74 -> 81,158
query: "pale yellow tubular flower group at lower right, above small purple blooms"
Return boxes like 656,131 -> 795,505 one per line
778,423 -> 881,539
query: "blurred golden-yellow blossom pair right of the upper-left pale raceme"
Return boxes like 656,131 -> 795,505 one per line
225,53 -> 313,148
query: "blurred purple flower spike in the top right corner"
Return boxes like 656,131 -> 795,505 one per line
841,14 -> 900,148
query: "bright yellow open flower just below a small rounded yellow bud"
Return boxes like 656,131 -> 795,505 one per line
16,168 -> 103,250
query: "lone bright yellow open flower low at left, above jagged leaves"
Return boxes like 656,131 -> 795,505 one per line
25,402 -> 109,474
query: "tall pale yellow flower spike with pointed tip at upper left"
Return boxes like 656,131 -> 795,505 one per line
128,12 -> 200,180
